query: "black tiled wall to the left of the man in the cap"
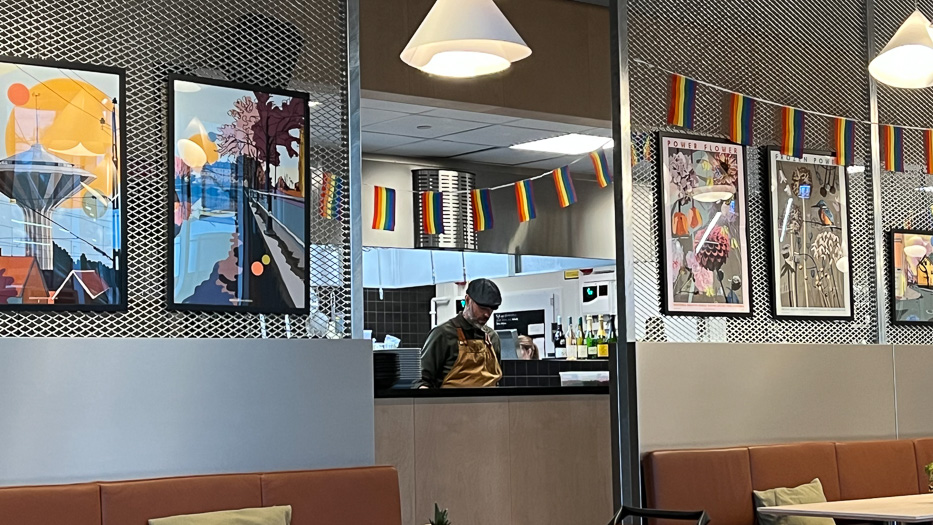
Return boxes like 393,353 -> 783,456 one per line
363,285 -> 436,348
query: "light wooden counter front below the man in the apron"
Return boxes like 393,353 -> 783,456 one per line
375,395 -> 612,525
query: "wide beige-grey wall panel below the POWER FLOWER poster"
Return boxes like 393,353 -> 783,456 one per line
636,343 -> 900,452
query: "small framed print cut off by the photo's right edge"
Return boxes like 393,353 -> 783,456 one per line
888,230 -> 933,325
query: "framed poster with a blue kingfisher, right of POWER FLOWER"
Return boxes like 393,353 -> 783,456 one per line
766,148 -> 853,320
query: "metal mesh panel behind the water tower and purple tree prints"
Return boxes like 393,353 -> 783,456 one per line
0,0 -> 350,338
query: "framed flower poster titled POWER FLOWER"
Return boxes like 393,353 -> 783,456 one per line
658,133 -> 752,316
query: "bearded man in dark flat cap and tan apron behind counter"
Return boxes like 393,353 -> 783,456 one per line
419,279 -> 502,388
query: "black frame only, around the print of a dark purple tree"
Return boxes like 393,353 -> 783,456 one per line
165,74 -> 311,314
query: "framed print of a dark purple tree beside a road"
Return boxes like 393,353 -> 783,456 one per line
167,76 -> 310,314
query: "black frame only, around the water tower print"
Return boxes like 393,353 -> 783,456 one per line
0,56 -> 129,312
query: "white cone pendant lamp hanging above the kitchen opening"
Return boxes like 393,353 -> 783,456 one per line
401,0 -> 531,78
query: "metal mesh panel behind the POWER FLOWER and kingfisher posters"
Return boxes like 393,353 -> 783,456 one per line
629,0 -> 876,344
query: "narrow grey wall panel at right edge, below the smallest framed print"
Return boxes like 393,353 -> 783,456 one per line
894,345 -> 933,438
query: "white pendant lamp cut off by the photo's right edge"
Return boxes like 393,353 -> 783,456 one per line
868,11 -> 933,88
